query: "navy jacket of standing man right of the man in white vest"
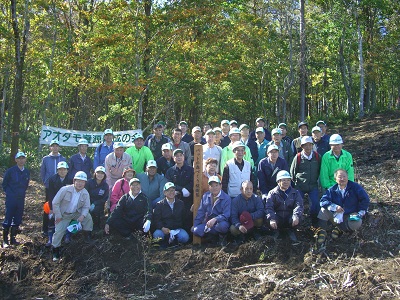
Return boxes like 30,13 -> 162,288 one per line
257,157 -> 289,195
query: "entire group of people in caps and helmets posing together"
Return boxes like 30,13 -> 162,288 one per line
3,118 -> 369,260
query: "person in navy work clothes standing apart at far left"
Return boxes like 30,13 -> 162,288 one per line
2,152 -> 30,248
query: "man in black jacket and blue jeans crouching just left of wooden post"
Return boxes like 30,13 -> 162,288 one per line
153,182 -> 189,246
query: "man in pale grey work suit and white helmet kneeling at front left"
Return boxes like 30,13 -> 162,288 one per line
52,171 -> 93,261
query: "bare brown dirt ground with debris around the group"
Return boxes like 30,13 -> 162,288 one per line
0,112 -> 400,299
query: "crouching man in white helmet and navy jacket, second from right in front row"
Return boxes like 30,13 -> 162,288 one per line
265,171 -> 303,242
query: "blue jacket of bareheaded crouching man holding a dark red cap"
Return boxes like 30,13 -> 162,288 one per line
231,194 -> 264,228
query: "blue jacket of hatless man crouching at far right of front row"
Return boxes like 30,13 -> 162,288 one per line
320,180 -> 369,215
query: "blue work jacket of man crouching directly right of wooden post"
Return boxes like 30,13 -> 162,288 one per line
193,190 -> 232,226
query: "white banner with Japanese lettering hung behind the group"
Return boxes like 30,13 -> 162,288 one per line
39,126 -> 142,147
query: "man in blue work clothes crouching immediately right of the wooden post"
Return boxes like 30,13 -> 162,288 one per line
193,176 -> 232,246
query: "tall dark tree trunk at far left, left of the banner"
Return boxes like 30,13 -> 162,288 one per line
10,0 -> 30,166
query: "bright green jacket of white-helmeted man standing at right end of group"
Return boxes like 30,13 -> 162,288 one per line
319,149 -> 354,189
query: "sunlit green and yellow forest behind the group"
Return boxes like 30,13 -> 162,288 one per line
0,0 -> 400,166
